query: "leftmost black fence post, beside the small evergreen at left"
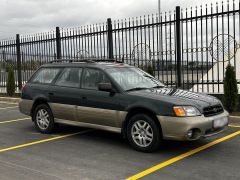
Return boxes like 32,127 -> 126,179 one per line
16,34 -> 22,90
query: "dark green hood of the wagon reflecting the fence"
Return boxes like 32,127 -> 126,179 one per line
129,87 -> 221,111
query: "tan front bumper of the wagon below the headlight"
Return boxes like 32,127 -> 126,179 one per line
157,111 -> 229,141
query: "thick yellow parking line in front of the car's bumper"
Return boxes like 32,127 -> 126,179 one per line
127,131 -> 240,180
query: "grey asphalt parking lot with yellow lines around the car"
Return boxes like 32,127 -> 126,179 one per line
0,102 -> 240,180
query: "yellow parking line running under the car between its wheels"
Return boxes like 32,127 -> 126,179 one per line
0,130 -> 93,153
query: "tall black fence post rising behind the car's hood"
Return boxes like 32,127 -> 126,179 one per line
176,6 -> 182,88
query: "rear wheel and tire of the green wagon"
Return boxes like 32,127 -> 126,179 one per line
32,104 -> 55,134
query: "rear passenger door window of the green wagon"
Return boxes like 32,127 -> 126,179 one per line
55,68 -> 82,88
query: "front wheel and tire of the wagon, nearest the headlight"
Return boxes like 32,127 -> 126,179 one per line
127,114 -> 162,152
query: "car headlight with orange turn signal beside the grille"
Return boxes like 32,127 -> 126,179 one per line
173,106 -> 201,117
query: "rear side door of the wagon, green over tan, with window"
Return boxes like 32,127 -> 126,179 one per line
49,67 -> 82,121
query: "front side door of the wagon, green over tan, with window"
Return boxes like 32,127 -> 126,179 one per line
77,68 -> 124,127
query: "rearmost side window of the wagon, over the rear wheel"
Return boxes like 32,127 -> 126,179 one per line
30,68 -> 61,84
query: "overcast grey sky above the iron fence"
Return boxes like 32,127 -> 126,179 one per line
0,0 -> 221,39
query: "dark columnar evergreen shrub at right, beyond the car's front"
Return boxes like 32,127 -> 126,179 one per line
224,64 -> 238,112
